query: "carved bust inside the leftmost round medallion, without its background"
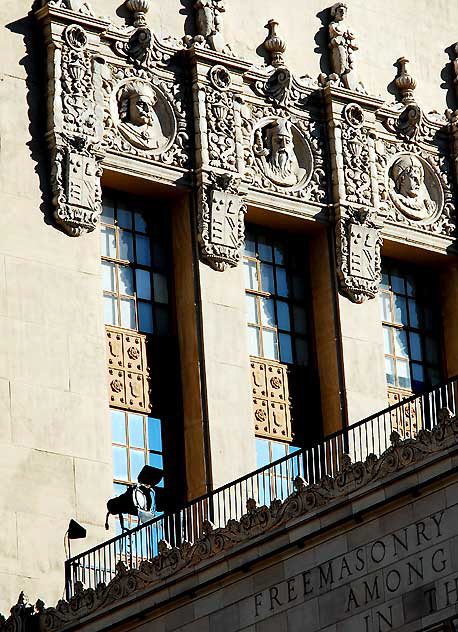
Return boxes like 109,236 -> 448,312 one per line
117,81 -> 167,150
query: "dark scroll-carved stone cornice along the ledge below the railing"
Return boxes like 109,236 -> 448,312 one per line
0,409 -> 458,632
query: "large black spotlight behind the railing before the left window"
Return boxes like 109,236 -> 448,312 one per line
105,465 -> 164,531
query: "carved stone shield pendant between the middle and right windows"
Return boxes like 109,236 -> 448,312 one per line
336,209 -> 383,303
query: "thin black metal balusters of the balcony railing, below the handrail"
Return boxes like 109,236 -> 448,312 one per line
65,377 -> 458,599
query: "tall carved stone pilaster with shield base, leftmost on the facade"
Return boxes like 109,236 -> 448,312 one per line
41,15 -> 103,236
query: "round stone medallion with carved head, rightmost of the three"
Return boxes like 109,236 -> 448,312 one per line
389,154 -> 443,222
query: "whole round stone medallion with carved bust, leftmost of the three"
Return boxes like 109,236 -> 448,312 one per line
114,79 -> 173,153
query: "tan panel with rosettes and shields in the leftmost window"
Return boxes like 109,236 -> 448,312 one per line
106,327 -> 151,413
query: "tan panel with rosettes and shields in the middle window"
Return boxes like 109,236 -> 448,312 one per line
251,358 -> 292,440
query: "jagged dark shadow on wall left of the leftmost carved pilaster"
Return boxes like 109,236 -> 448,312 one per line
5,1 -> 54,230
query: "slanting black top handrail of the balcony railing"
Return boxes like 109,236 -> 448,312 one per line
66,375 -> 458,566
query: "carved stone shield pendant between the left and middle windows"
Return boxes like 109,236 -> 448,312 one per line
198,174 -> 247,272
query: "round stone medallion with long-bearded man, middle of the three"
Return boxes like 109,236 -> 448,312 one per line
253,118 -> 312,187
